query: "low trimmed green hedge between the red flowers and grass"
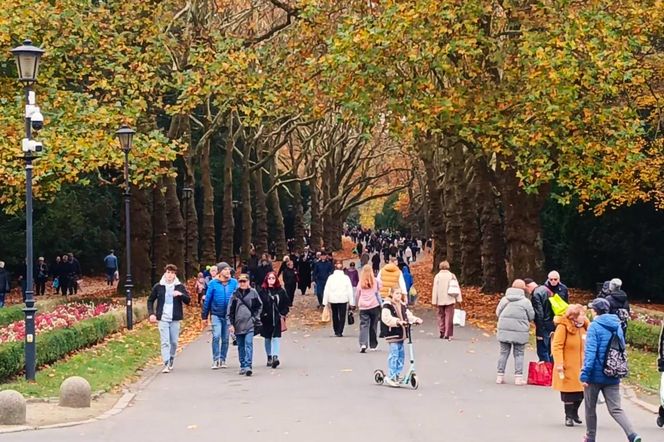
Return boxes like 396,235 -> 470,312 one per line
0,305 -> 147,382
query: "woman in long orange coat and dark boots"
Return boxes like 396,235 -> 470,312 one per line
551,304 -> 589,427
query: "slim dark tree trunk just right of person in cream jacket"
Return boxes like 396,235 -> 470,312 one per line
452,144 -> 482,285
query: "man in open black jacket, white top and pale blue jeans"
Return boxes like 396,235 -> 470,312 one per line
148,264 -> 191,373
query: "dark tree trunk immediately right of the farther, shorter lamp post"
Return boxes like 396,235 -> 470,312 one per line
127,189 -> 152,294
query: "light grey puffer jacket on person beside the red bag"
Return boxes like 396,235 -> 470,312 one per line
496,287 -> 535,344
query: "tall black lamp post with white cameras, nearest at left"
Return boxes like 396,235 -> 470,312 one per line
11,40 -> 44,381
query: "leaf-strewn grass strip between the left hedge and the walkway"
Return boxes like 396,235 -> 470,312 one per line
2,321 -> 159,398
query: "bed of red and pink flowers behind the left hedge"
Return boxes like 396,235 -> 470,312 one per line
0,303 -> 113,344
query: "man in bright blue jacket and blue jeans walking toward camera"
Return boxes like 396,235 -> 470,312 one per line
201,262 -> 238,370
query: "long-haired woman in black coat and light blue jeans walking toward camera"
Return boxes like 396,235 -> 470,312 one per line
259,272 -> 293,368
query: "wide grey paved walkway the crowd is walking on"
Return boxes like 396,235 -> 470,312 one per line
2,312 -> 664,442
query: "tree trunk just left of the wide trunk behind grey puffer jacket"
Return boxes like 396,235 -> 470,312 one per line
471,157 -> 508,293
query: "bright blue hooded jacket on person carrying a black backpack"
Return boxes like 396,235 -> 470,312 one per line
581,313 -> 625,384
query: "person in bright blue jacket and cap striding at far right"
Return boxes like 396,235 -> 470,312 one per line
581,298 -> 641,442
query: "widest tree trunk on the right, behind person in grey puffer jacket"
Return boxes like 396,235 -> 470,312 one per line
496,159 -> 548,281
